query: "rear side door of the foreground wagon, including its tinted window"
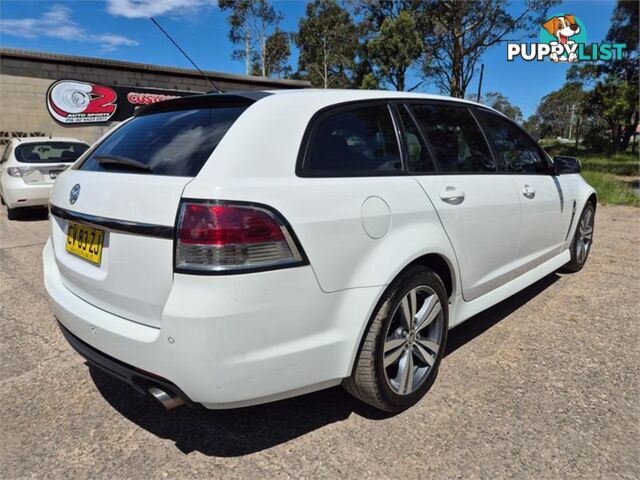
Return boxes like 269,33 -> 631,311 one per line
401,102 -> 520,301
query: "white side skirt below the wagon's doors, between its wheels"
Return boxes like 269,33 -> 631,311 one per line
449,250 -> 571,329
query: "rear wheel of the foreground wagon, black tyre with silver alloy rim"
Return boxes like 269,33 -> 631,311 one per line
343,266 -> 449,412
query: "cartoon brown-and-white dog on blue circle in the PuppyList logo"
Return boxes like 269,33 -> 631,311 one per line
540,14 -> 587,62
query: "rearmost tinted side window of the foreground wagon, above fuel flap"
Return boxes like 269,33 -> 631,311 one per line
304,105 -> 402,175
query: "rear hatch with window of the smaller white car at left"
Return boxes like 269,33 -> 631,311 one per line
15,141 -> 89,185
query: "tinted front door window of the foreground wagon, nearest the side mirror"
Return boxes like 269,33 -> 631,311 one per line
480,111 -> 548,173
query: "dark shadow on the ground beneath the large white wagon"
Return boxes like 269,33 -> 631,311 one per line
91,274 -> 560,457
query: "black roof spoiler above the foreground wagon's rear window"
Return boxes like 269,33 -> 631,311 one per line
133,90 -> 272,117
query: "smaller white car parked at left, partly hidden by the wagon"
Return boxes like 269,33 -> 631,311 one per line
0,137 -> 89,220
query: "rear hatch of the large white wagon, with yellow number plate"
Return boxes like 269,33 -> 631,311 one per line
51,95 -> 253,327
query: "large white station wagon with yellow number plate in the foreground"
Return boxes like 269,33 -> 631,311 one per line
44,90 -> 596,412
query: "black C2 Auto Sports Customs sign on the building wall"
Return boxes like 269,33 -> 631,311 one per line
47,80 -> 200,125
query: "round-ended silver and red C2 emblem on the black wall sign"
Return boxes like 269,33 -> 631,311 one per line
47,80 -> 118,124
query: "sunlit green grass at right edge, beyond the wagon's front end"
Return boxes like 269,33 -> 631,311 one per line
541,140 -> 640,207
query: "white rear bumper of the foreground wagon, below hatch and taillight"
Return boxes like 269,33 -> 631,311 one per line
43,241 -> 384,408
